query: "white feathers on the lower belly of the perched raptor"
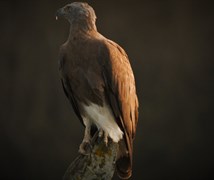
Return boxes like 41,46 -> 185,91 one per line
83,103 -> 123,142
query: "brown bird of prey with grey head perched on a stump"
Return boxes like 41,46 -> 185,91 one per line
56,2 -> 138,179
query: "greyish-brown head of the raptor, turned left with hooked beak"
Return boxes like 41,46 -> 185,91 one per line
56,2 -> 96,28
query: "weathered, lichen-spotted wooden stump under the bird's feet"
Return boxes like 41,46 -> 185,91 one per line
63,134 -> 118,180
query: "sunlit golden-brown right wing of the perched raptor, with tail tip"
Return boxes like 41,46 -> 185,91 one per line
103,40 -> 138,178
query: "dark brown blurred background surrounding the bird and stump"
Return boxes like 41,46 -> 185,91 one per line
0,0 -> 214,180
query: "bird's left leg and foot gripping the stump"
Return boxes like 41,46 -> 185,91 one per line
79,119 -> 91,155
